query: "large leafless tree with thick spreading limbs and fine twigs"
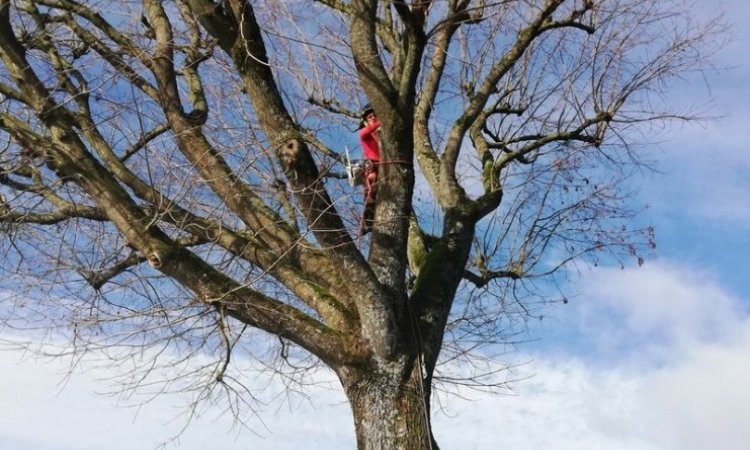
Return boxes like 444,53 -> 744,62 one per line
0,0 -> 725,449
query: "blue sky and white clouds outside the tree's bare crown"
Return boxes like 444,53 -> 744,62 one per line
0,0 -> 750,450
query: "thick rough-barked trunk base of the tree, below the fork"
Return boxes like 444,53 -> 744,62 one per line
339,363 -> 438,450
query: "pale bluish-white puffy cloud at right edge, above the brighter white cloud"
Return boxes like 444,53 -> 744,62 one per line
579,262 -> 744,353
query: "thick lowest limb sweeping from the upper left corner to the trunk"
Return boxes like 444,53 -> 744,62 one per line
0,3 -> 360,363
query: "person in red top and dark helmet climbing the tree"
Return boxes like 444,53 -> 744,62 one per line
359,104 -> 380,235
